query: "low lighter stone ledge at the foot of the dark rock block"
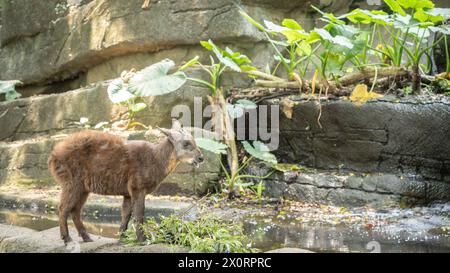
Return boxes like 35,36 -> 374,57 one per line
265,166 -> 442,206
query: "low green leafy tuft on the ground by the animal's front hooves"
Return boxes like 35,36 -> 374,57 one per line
125,214 -> 257,253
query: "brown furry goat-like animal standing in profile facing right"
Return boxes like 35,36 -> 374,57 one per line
48,120 -> 203,243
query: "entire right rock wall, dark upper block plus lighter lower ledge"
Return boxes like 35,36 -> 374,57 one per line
253,96 -> 450,206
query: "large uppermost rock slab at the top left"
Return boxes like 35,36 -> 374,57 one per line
0,0 -> 271,84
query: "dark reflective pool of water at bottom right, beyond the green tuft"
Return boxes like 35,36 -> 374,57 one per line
244,216 -> 450,253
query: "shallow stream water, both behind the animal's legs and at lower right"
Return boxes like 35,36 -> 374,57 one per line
0,205 -> 450,252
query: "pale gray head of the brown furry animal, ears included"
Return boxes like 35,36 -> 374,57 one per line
158,119 -> 204,168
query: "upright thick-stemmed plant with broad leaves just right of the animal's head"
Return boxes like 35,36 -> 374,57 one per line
179,40 -> 276,199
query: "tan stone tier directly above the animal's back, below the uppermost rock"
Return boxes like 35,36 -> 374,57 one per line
0,79 -> 215,141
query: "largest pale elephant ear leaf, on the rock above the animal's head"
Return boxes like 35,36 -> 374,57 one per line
128,59 -> 187,96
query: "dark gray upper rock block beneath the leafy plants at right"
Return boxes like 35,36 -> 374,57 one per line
270,98 -> 450,183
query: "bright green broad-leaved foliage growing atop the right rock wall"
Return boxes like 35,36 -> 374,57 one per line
241,0 -> 450,92
